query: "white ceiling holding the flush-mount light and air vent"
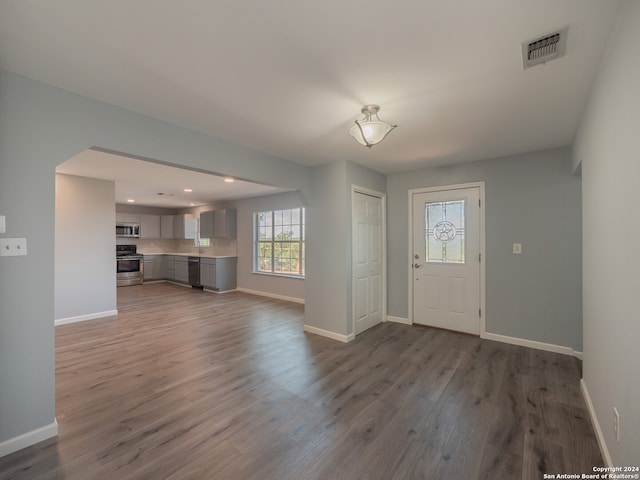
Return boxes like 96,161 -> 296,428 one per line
0,0 -> 618,178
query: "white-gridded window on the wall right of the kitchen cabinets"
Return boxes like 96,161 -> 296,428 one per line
254,208 -> 305,277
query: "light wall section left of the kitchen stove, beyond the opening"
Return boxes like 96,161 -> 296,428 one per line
55,174 -> 117,320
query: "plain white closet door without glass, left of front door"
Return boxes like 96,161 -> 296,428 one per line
352,192 -> 384,335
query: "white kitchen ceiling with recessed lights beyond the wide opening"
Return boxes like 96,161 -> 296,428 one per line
56,149 -> 285,208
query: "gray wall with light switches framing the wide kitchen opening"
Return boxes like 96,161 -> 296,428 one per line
0,72 -> 322,445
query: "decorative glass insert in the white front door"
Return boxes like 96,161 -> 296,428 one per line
424,200 -> 465,264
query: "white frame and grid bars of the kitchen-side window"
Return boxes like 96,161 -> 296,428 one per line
253,207 -> 306,279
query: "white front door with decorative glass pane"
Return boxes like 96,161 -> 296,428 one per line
411,186 -> 481,335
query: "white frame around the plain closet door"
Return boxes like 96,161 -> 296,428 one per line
349,184 -> 387,340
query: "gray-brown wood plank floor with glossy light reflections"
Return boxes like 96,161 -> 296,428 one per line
0,283 -> 603,480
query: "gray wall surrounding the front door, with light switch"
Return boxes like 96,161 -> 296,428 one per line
387,149 -> 582,351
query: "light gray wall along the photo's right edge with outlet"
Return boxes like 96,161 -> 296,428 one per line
574,1 -> 640,466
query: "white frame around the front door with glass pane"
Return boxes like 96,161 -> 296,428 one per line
407,181 -> 487,338
